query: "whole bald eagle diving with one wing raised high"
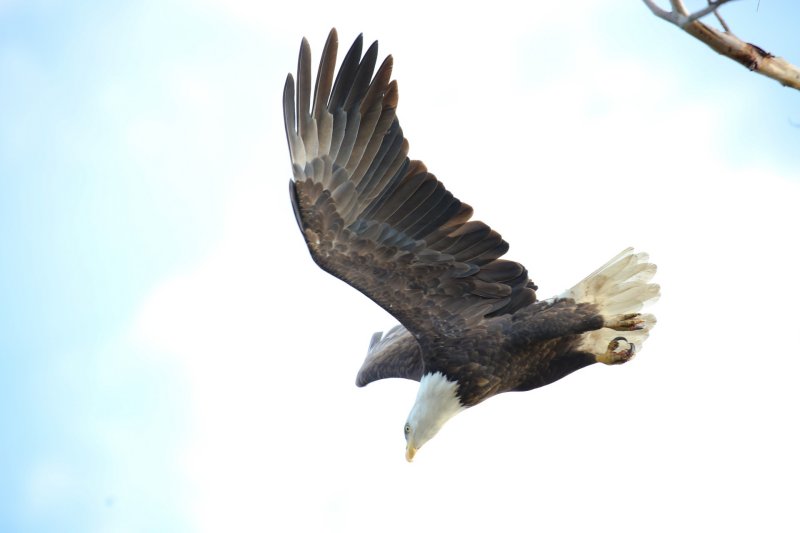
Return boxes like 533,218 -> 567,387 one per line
283,29 -> 659,461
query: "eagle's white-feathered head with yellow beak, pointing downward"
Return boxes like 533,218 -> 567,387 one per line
403,372 -> 466,462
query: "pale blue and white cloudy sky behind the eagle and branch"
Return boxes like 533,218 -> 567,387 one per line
0,0 -> 800,533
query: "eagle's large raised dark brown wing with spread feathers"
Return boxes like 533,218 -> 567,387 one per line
283,30 -> 536,350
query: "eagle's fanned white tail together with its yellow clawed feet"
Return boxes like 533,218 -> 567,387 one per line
563,248 -> 660,363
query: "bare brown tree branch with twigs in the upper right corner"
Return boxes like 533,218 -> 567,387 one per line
642,0 -> 800,90
